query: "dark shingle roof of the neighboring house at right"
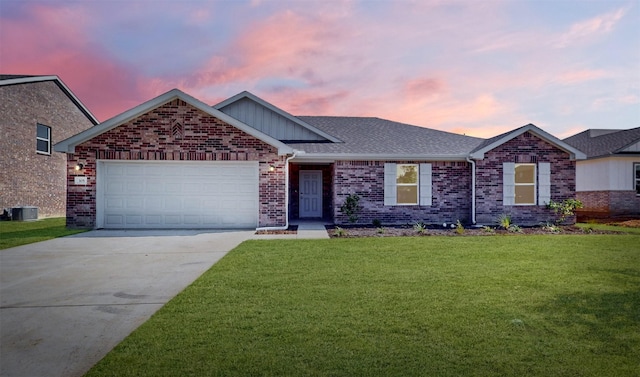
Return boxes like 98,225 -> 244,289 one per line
564,127 -> 640,158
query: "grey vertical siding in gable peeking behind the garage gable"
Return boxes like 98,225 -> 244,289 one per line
220,98 -> 325,141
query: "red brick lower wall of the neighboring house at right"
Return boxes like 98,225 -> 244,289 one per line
576,191 -> 640,218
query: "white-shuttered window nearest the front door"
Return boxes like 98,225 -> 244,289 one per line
384,163 -> 432,206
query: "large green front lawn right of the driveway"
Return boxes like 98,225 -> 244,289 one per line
88,235 -> 640,376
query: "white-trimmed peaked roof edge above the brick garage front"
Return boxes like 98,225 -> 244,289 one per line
54,89 -> 293,155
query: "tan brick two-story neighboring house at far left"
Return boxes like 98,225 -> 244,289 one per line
0,75 -> 98,217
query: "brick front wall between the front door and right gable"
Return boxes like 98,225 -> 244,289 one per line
333,161 -> 471,225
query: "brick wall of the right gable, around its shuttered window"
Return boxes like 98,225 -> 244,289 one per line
476,132 -> 576,225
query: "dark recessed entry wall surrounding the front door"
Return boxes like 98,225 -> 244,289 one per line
289,164 -> 333,221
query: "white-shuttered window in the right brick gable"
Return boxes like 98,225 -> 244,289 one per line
502,162 -> 551,206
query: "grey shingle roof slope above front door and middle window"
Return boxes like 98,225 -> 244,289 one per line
289,116 -> 484,157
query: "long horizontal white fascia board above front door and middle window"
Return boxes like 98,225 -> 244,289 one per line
292,153 -> 468,162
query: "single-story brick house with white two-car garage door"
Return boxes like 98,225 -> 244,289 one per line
55,89 -> 585,228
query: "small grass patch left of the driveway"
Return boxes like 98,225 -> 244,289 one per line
0,218 -> 86,250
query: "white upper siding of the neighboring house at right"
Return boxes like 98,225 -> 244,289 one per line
576,157 -> 640,192
